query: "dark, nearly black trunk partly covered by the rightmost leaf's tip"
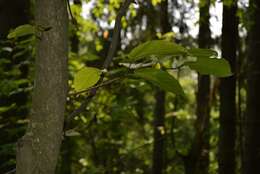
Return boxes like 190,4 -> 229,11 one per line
219,1 -> 238,174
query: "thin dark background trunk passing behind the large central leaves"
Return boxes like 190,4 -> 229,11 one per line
152,0 -> 171,174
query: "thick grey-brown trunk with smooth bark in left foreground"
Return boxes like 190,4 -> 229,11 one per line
16,0 -> 68,174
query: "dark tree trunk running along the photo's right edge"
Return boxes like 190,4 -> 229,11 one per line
244,0 -> 260,174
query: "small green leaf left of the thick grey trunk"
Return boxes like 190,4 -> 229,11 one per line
7,24 -> 35,39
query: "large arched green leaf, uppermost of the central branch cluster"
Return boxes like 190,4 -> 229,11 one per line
128,40 -> 187,61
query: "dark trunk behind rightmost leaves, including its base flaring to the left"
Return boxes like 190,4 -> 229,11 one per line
185,0 -> 211,174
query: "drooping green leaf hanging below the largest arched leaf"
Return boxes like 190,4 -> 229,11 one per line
134,68 -> 184,96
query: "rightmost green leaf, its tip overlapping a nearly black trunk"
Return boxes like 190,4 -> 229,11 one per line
185,58 -> 232,77
